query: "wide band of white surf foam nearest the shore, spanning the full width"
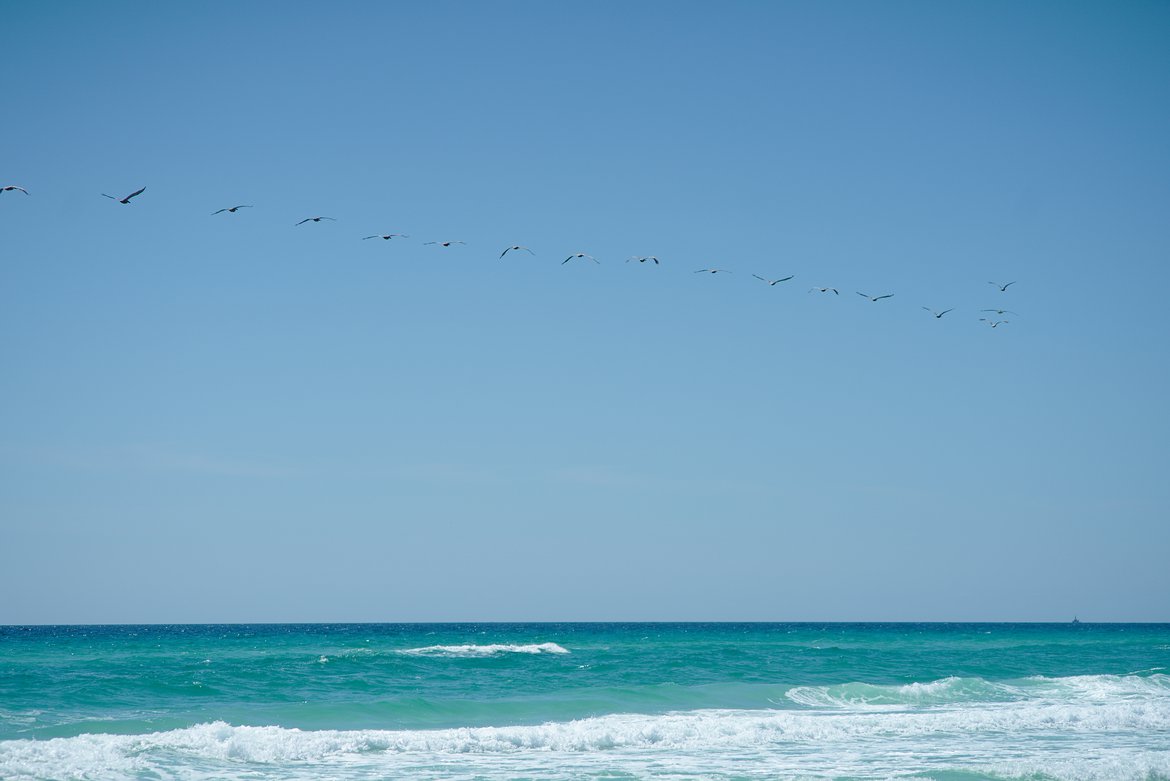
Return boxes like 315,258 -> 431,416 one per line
0,698 -> 1170,780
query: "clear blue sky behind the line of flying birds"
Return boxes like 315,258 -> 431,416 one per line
0,0 -> 1170,623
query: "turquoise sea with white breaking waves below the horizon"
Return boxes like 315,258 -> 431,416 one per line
0,623 -> 1170,781
